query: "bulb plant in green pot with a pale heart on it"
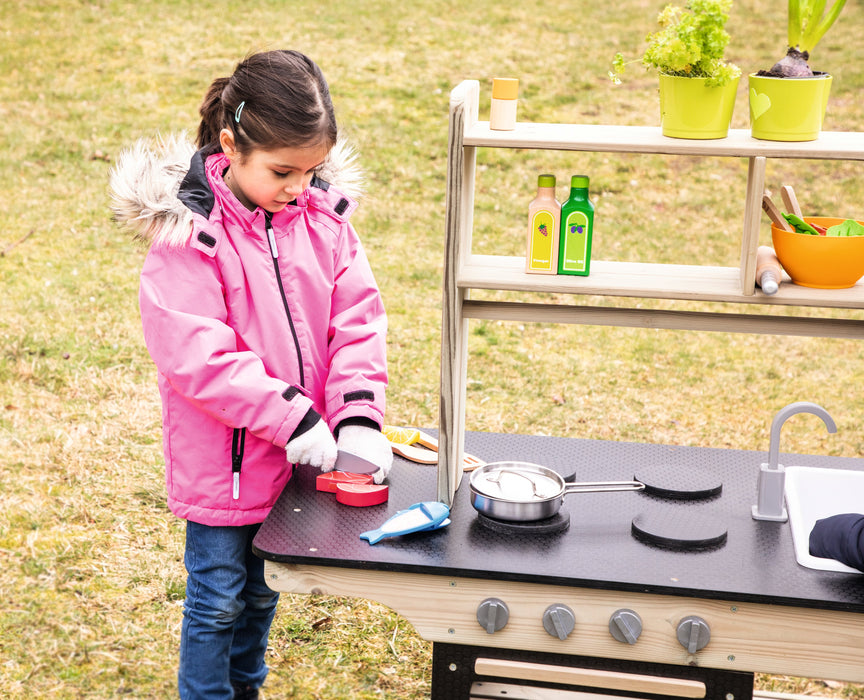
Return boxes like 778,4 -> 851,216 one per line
749,0 -> 846,141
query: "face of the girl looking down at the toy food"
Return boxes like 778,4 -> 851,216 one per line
220,129 -> 329,213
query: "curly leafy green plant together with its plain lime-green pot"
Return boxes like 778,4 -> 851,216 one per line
609,0 -> 741,139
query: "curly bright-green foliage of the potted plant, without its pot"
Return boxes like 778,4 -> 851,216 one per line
609,0 -> 740,86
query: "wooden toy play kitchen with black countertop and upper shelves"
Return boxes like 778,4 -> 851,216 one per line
255,81 -> 864,700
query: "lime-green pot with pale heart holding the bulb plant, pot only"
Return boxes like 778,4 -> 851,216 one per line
750,73 -> 831,141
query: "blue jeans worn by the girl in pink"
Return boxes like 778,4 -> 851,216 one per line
178,521 -> 279,700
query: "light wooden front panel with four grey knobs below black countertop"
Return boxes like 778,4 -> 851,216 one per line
267,562 -> 864,684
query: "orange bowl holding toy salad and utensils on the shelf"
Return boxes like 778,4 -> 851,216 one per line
771,216 -> 864,289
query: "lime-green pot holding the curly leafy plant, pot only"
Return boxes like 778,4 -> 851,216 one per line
660,73 -> 738,139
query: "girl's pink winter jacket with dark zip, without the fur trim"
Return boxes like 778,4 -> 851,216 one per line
114,139 -> 387,525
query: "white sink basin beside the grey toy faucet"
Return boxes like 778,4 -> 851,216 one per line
786,467 -> 864,574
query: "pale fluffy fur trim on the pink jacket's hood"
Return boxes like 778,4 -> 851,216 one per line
110,134 -> 363,246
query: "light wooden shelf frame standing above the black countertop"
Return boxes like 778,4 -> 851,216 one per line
438,80 -> 864,503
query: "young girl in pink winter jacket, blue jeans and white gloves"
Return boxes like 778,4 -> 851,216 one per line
112,51 -> 393,700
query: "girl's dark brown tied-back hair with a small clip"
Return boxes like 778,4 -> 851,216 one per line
197,51 -> 337,156
